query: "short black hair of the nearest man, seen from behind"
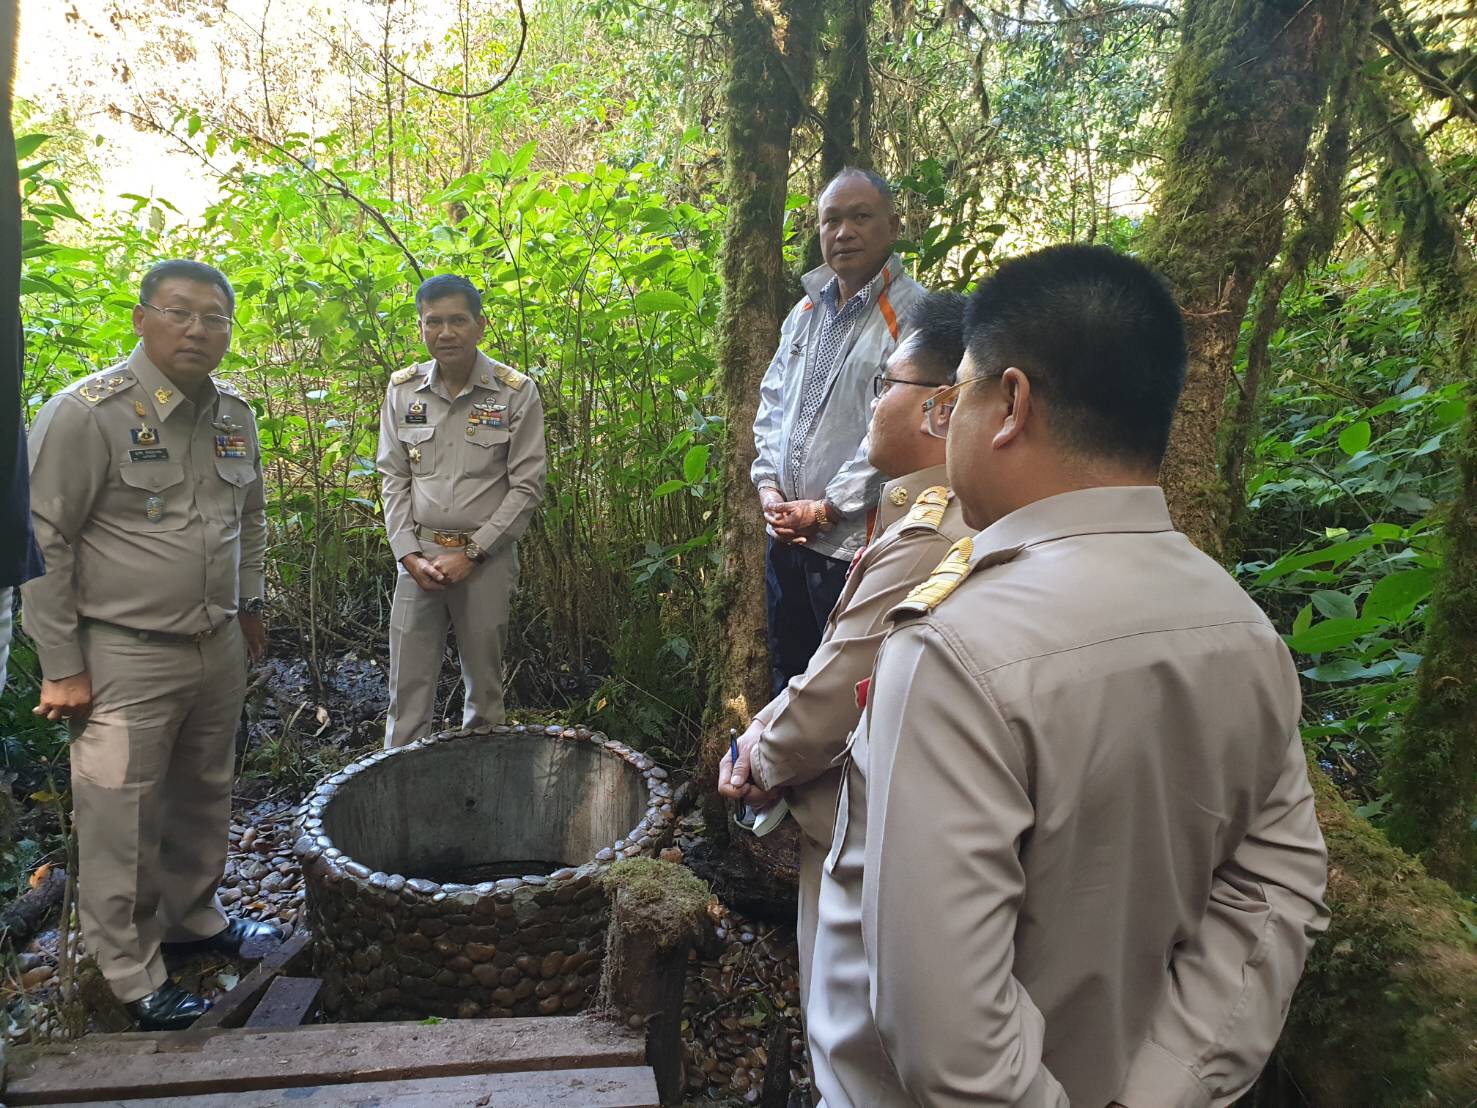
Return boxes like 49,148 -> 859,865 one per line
964,244 -> 1188,467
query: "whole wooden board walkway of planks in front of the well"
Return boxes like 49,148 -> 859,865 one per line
3,1016 -> 657,1108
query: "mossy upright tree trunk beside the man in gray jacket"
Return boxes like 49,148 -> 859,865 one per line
702,0 -> 820,803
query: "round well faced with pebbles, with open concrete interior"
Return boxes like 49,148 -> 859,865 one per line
294,725 -> 674,1019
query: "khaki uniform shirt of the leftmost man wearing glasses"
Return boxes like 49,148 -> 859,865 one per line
22,343 -> 267,681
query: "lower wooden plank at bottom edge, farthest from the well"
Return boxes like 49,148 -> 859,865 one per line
63,1065 -> 659,1108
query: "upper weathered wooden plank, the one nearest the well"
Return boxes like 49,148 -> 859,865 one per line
6,1016 -> 645,1105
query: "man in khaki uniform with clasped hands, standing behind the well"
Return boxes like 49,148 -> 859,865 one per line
380,276 -> 548,748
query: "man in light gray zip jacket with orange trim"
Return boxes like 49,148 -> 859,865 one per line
749,167 -> 923,696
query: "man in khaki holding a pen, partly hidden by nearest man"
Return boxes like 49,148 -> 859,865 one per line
718,293 -> 969,997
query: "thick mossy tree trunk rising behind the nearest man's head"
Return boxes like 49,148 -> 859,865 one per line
1143,0 -> 1359,557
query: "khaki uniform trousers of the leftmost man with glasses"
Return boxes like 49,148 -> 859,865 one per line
69,620 -> 247,1002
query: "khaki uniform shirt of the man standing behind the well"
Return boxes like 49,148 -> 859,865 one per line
378,352 -> 548,561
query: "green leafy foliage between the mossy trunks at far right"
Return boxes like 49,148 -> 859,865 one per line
1238,263 -> 1467,820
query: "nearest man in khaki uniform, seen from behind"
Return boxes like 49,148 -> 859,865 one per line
806,247 -> 1326,1108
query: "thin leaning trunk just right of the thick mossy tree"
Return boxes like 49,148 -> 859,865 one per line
1221,0 -> 1374,535
